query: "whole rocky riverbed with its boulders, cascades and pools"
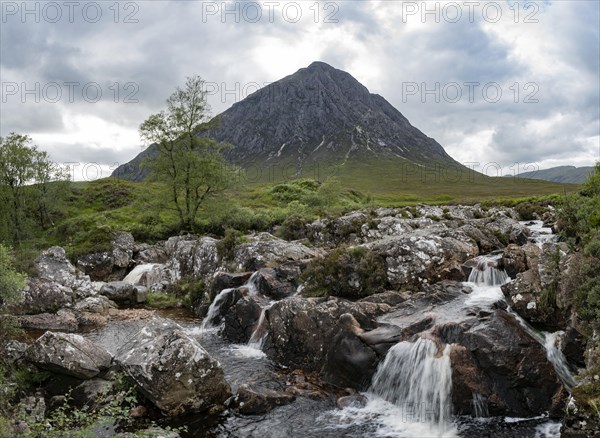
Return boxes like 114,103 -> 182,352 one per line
2,206 -> 585,437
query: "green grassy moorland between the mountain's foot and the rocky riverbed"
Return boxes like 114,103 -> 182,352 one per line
9,163 -> 577,268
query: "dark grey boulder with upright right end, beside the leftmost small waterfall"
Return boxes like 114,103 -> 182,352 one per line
77,231 -> 135,281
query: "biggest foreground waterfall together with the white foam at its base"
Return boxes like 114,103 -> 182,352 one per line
321,339 -> 457,438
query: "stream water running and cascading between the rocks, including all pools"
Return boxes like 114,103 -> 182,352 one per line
70,222 -> 574,438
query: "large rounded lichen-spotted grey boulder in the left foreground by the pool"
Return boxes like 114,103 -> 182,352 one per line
115,318 -> 231,415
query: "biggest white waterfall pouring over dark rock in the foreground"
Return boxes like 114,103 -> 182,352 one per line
370,338 -> 452,434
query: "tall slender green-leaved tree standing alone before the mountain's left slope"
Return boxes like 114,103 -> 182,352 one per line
140,76 -> 233,231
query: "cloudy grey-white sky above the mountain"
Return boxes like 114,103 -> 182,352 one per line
0,0 -> 600,179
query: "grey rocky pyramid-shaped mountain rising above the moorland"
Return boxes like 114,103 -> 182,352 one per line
113,62 -> 466,181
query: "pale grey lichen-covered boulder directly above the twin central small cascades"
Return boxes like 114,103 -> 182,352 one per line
234,233 -> 323,271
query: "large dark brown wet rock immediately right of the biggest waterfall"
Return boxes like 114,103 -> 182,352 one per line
435,310 -> 564,417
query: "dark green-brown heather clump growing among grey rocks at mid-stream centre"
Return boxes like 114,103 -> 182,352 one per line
303,246 -> 387,299
